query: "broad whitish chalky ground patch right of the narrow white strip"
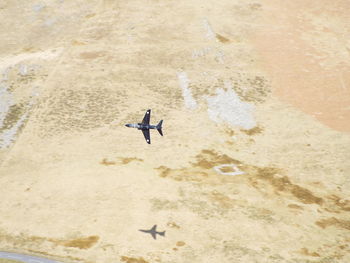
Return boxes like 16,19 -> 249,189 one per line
206,82 -> 256,130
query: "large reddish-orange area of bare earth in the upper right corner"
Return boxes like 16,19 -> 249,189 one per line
253,0 -> 350,132
